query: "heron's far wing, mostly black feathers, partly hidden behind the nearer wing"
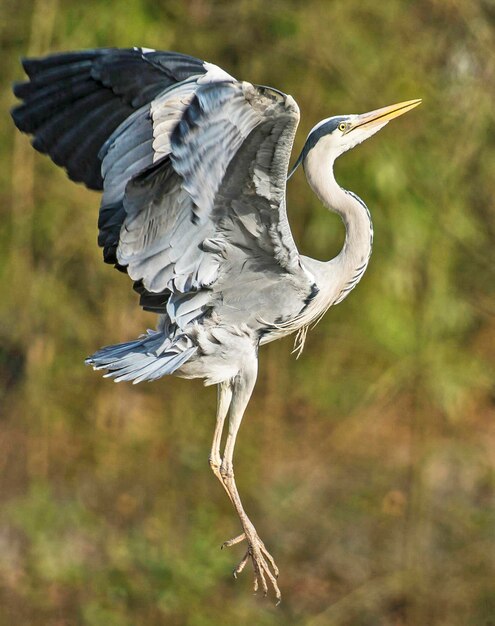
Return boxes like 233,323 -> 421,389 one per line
12,48 -> 234,269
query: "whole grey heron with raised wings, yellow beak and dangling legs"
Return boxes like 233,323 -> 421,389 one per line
12,48 -> 420,600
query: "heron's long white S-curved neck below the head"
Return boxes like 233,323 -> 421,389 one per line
304,146 -> 373,304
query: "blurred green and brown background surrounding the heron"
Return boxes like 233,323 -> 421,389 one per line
0,0 -> 495,626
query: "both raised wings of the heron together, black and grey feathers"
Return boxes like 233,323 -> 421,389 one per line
12,48 -> 314,326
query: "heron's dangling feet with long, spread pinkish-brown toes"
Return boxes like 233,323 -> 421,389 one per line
222,526 -> 282,604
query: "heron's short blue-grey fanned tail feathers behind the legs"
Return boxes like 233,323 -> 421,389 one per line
85,330 -> 197,384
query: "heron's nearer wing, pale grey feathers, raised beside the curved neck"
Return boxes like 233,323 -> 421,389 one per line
113,81 -> 313,327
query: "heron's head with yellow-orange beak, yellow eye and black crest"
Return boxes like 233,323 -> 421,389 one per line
288,100 -> 421,178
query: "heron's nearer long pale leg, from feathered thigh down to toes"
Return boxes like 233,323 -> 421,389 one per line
220,361 -> 281,601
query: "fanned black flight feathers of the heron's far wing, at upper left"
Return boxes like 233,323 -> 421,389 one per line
12,48 -> 220,190
